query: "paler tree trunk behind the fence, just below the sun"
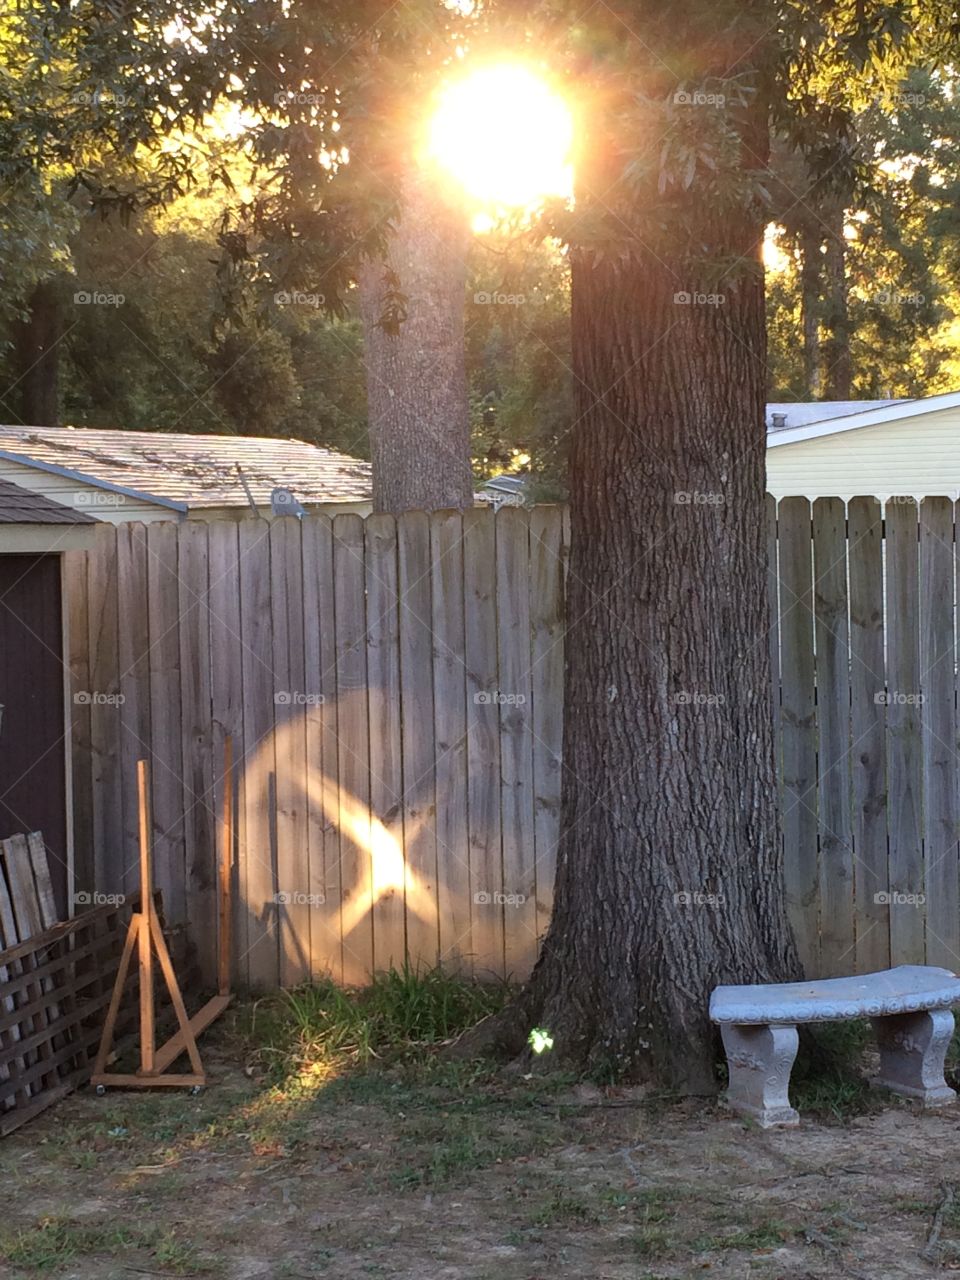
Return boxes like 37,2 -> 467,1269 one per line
360,177 -> 474,513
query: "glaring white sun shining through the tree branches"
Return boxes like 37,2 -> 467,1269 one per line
429,63 -> 573,209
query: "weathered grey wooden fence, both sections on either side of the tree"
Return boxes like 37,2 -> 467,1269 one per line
68,498 -> 960,986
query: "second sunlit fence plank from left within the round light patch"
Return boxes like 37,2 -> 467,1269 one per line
270,516 -> 309,987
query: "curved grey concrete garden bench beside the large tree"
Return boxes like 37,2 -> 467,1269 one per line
710,964 -> 960,1129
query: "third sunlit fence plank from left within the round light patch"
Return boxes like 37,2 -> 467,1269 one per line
301,516 -> 343,982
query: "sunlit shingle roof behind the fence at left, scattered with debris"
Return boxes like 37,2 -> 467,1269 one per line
0,426 -> 371,507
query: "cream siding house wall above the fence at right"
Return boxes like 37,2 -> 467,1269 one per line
767,408 -> 960,499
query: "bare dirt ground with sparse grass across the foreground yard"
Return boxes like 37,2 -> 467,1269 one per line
0,1027 -> 960,1280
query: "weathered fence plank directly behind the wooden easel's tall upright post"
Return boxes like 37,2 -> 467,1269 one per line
117,521 -> 152,897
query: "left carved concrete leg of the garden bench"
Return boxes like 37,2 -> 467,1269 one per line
721,1024 -> 800,1129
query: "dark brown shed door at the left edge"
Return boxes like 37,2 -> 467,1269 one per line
0,556 -> 67,919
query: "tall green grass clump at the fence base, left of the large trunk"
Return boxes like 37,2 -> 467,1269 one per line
240,966 -> 509,1076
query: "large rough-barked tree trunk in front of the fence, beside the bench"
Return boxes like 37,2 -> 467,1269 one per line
481,227 -> 799,1093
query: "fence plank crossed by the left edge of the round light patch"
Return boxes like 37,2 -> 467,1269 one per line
239,520 -> 280,988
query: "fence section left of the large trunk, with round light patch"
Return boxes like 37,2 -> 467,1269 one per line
68,507 -> 564,986
